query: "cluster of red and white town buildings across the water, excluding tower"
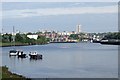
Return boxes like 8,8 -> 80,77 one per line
38,30 -> 77,42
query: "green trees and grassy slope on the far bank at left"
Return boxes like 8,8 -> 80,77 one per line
0,33 -> 49,46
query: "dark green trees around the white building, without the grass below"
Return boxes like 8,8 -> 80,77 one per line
0,33 -> 49,44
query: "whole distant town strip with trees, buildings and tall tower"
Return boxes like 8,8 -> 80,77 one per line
1,25 -> 120,45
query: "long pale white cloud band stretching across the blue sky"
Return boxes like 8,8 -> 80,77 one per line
3,6 -> 118,18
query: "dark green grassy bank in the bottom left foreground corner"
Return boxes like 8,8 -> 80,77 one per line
0,66 -> 30,80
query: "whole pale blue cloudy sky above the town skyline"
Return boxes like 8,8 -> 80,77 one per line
1,2 -> 118,32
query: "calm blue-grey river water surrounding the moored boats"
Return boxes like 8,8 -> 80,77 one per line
2,43 -> 118,78
